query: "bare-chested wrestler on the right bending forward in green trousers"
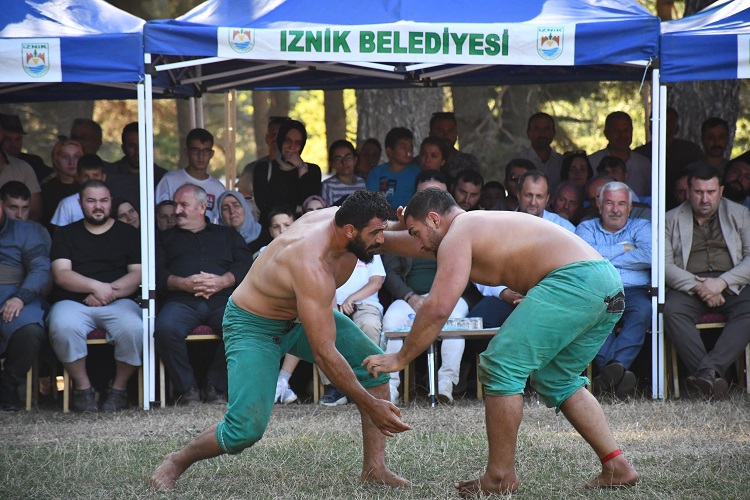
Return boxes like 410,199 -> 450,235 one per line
365,188 -> 638,496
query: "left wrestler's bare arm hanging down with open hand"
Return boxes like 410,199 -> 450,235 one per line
293,266 -> 409,436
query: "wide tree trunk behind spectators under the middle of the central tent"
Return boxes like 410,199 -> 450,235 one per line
355,88 -> 444,161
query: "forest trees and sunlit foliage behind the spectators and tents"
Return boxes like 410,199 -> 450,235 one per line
0,0 -> 750,186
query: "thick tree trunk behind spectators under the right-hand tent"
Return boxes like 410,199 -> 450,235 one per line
668,0 -> 740,151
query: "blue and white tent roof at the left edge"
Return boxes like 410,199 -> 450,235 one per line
0,0 -> 145,102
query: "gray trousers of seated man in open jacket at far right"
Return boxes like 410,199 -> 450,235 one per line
664,287 -> 750,377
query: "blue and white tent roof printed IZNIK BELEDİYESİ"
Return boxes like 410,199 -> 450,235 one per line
144,0 -> 659,91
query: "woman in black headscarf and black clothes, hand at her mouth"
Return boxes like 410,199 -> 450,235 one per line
253,120 -> 321,224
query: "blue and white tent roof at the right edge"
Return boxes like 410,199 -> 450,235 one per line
660,0 -> 750,82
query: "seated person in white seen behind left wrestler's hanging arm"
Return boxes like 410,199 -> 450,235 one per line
320,255 -> 385,406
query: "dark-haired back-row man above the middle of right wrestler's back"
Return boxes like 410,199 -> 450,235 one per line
513,112 -> 563,190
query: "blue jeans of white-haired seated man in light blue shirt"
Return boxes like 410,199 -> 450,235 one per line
594,287 -> 651,370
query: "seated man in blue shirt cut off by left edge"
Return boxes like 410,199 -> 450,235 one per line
0,191 -> 50,411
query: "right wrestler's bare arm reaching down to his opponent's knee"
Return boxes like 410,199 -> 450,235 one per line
364,235 -> 471,376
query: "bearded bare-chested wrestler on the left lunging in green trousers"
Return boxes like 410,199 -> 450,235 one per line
149,191 -> 410,490
